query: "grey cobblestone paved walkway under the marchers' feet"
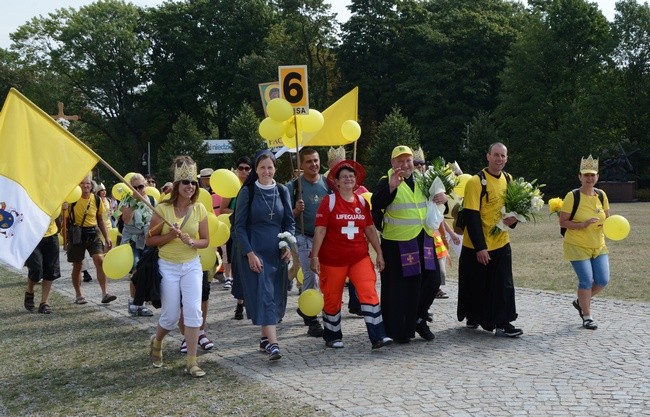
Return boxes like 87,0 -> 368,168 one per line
26,249 -> 650,417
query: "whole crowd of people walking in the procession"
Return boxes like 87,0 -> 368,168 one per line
24,143 -> 609,377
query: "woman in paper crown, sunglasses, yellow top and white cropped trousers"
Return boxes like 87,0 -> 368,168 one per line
146,156 -> 209,378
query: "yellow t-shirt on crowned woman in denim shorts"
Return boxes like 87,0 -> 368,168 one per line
562,191 -> 609,261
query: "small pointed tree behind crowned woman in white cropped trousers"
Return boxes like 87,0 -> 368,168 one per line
157,114 -> 212,178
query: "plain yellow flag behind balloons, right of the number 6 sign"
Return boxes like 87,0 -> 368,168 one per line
302,87 -> 359,146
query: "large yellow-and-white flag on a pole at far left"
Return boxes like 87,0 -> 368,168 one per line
0,88 -> 99,268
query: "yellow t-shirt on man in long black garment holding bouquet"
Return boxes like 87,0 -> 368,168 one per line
463,170 -> 510,251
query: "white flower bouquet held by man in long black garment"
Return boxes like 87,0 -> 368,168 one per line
490,178 -> 544,236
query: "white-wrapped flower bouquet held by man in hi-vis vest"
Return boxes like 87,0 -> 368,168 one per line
413,157 -> 458,230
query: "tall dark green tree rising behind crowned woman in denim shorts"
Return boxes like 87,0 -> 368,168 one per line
495,0 -> 611,194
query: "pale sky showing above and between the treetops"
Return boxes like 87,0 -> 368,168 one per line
0,0 -> 616,49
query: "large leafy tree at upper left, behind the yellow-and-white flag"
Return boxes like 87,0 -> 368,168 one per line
12,0 -> 150,176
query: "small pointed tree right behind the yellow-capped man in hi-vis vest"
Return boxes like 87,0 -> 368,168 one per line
364,107 -> 420,190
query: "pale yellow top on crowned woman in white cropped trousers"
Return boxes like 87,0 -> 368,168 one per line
156,203 -> 208,264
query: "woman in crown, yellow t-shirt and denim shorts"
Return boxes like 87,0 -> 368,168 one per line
560,155 -> 609,330
